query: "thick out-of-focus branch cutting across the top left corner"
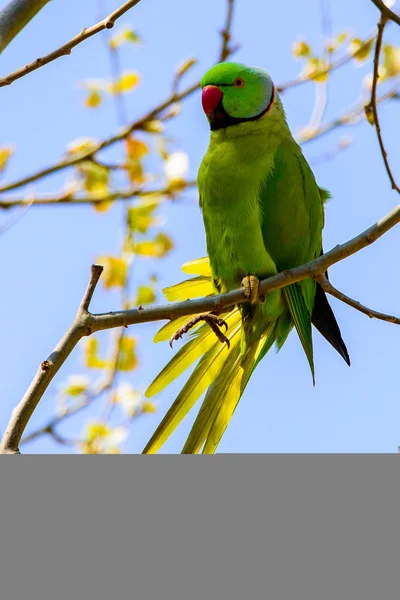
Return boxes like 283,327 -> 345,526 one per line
0,0 -> 49,54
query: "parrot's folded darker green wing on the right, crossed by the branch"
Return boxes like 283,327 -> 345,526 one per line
260,139 -> 324,380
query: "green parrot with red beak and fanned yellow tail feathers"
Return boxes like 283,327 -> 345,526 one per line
144,62 -> 350,454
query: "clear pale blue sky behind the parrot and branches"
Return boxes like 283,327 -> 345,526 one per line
0,0 -> 400,453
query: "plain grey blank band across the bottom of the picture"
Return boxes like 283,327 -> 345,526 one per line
0,455 -> 400,600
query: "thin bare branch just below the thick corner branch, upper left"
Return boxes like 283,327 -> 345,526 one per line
0,0 -> 140,87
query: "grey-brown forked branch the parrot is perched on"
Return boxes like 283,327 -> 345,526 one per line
0,199 -> 400,454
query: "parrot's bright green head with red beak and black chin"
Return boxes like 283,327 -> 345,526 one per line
201,62 -> 276,131
